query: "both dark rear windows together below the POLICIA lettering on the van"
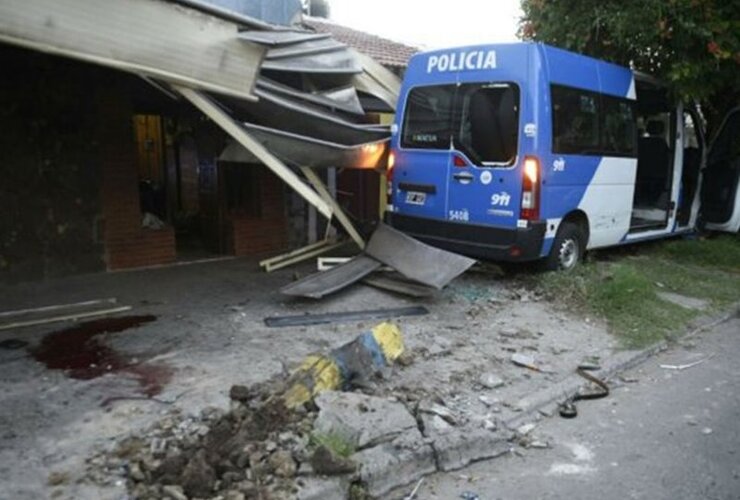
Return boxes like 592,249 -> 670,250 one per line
401,83 -> 519,165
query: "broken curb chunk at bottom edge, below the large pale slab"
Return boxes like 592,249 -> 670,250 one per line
352,429 -> 437,498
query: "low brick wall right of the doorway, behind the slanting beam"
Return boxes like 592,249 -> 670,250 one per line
228,165 -> 288,256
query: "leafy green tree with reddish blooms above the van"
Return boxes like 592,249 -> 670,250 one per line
519,0 -> 740,135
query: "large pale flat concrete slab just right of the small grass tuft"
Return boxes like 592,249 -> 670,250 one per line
314,391 -> 418,449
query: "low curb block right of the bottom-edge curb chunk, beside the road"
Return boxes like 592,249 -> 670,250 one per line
432,429 -> 509,472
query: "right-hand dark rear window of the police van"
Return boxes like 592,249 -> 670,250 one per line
455,84 -> 519,165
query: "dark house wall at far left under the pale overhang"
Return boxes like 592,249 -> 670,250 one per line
0,45 -> 105,282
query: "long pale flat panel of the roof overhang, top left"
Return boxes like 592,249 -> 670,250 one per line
0,0 -> 265,100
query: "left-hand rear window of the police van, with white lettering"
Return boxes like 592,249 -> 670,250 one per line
401,85 -> 456,149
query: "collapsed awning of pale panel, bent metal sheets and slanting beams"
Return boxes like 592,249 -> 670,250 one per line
0,0 -> 400,266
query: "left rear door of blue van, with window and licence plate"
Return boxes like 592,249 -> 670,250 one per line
393,84 -> 457,219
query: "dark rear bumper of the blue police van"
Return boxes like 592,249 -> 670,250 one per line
385,212 -> 546,262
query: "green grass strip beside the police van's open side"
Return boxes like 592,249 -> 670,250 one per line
536,235 -> 740,348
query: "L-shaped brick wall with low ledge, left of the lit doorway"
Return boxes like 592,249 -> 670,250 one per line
97,78 -> 177,270
